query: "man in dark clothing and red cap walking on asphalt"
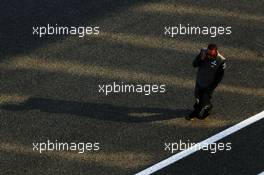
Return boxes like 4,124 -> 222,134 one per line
186,44 -> 226,120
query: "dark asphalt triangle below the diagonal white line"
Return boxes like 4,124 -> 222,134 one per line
155,119 -> 264,175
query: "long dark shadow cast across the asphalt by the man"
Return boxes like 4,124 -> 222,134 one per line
0,98 -> 190,123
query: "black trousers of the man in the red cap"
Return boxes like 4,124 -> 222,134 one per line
193,83 -> 213,113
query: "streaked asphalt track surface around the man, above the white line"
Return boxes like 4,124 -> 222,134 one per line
0,0 -> 264,175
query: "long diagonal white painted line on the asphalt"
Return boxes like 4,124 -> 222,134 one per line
136,111 -> 264,175
